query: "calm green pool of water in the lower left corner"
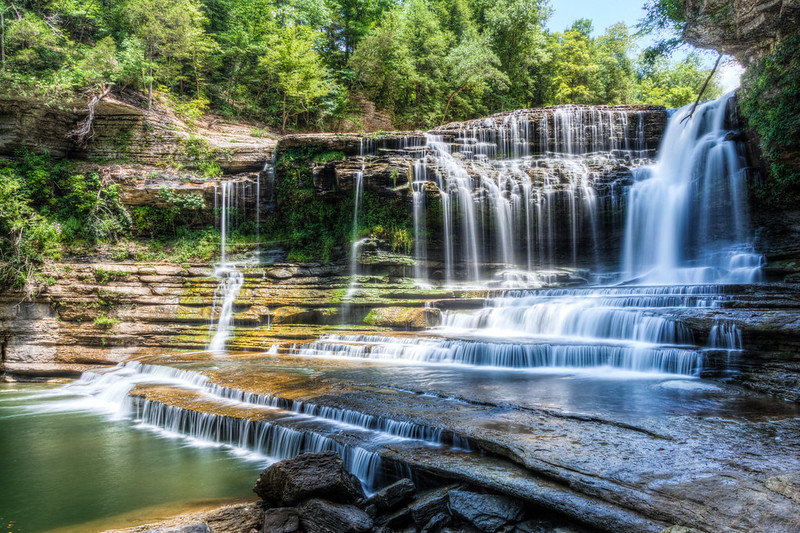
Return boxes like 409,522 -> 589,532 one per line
0,384 -> 266,533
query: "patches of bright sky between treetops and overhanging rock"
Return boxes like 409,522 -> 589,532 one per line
547,0 -> 742,92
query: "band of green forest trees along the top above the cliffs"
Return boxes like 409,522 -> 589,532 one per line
0,0 -> 719,130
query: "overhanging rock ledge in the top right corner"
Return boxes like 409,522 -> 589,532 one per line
683,0 -> 800,65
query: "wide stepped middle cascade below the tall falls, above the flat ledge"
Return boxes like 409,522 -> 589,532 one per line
294,285 -> 733,376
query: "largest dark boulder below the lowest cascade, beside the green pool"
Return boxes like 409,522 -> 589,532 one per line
253,452 -> 364,506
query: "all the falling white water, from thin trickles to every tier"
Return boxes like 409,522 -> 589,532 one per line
36,97 -> 760,516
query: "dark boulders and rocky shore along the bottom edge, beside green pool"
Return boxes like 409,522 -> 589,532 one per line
107,452 -> 591,533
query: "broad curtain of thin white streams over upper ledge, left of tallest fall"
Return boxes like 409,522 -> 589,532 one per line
411,106 -> 653,284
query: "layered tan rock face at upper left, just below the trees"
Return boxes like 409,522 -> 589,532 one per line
0,93 -> 276,174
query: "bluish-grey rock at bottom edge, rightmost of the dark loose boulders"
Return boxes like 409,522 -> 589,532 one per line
450,490 -> 523,533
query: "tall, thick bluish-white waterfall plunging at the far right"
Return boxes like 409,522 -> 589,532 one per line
623,94 -> 762,284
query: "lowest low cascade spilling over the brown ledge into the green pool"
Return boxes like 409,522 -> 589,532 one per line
54,362 -> 482,489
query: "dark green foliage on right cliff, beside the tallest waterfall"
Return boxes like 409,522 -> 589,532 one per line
741,34 -> 800,206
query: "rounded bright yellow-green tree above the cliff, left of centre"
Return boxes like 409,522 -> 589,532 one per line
260,26 -> 333,131
